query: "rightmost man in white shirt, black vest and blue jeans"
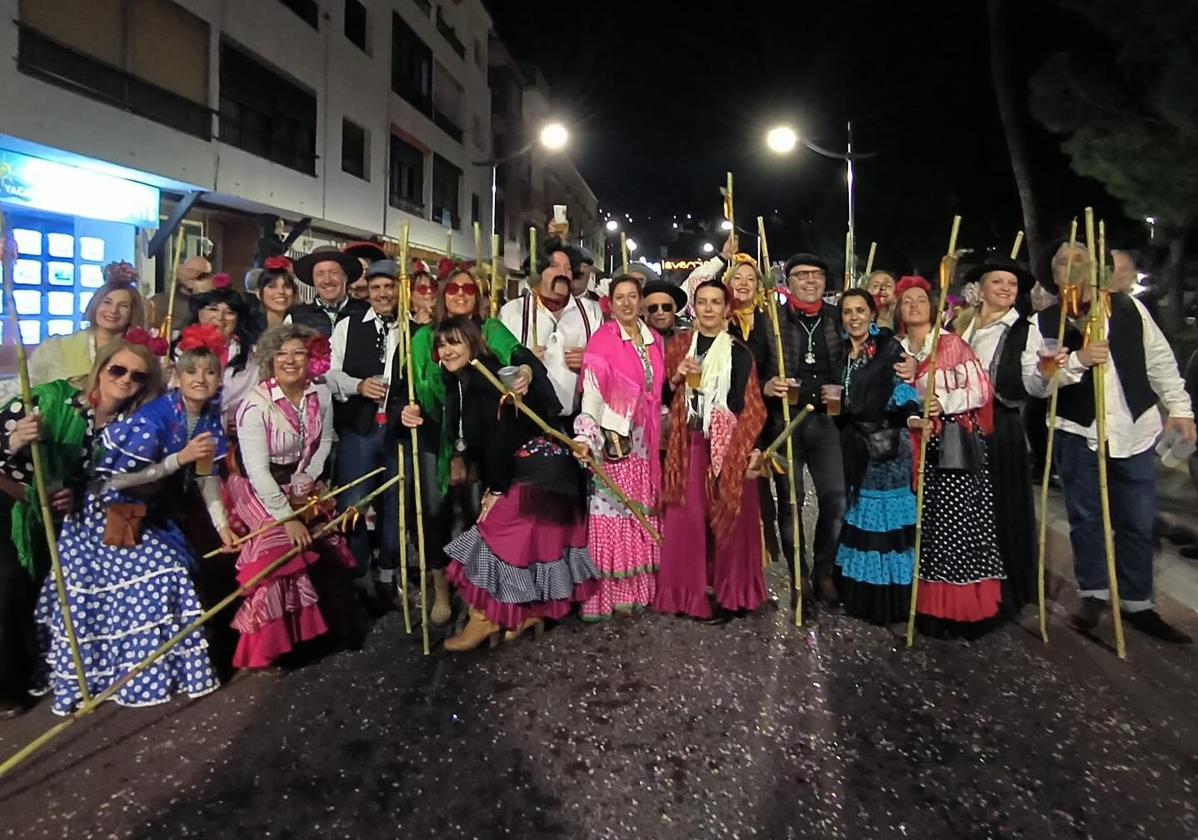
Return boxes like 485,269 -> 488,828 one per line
1040,244 -> 1196,643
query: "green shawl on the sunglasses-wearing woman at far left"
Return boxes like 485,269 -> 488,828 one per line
10,379 -> 87,575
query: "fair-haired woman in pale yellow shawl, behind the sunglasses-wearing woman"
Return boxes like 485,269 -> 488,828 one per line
29,262 -> 146,386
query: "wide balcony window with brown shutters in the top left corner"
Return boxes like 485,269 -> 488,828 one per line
17,0 -> 212,139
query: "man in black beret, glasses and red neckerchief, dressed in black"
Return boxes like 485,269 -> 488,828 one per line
762,254 -> 846,604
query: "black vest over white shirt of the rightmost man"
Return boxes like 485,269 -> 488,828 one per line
1040,294 -> 1157,427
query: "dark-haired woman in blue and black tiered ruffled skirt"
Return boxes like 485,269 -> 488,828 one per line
836,289 -> 920,624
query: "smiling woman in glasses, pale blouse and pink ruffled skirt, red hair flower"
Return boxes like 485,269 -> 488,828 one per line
228,324 -> 356,667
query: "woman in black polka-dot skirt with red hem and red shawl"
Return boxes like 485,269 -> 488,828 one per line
896,277 -> 1004,637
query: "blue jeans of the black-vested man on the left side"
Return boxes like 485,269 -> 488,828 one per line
333,427 -> 399,578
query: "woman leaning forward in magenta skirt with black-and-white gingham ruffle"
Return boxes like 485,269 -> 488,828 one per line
403,315 -> 599,653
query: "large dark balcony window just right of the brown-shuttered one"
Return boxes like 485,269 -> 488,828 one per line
220,42 -> 316,175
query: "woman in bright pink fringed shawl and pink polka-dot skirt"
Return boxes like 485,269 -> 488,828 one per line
574,274 -> 665,621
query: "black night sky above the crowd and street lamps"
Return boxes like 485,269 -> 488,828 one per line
488,0 -> 1126,278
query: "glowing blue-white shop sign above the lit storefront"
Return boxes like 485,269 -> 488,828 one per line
0,149 -> 158,228
